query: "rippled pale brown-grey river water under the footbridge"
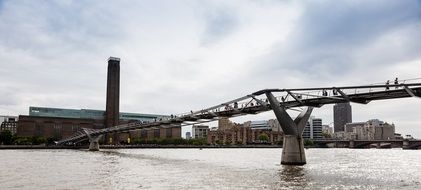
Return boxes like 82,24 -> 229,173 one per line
0,148 -> 421,189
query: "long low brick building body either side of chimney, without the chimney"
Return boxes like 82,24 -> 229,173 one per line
17,107 -> 176,143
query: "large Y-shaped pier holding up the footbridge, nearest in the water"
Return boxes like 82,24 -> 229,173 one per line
266,92 -> 313,165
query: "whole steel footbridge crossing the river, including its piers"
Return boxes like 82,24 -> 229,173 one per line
56,81 -> 421,165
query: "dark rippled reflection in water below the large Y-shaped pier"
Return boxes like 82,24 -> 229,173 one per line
278,165 -> 310,189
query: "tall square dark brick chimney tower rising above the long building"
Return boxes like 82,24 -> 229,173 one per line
105,57 -> 120,143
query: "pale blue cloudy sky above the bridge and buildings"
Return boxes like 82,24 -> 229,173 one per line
0,0 -> 421,138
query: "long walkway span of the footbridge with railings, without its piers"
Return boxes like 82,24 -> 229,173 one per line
57,83 -> 421,144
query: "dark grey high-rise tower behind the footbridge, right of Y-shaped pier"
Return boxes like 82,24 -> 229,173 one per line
333,102 -> 352,133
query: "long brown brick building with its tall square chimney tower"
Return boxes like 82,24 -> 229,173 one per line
17,57 -> 181,144
